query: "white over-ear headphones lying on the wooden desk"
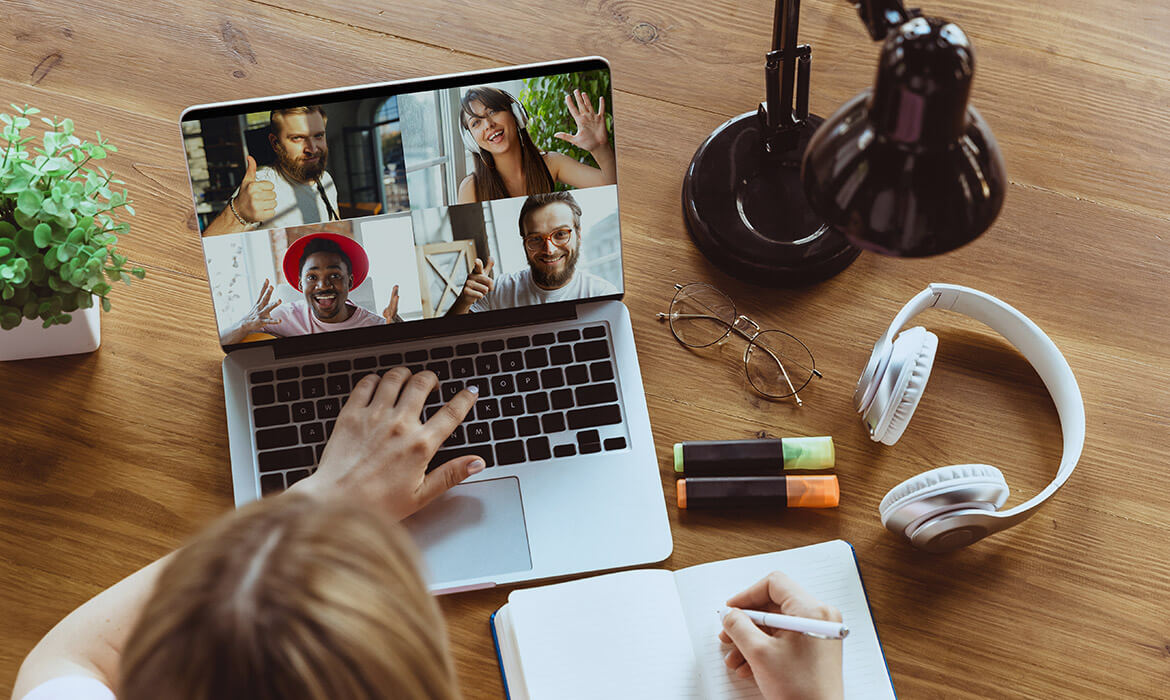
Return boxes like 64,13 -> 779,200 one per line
853,284 -> 1085,553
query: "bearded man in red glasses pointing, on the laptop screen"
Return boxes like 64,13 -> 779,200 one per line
447,192 -> 618,316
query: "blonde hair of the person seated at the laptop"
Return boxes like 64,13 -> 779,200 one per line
117,494 -> 457,700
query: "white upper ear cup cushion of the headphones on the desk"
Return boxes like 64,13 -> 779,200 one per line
870,325 -> 938,445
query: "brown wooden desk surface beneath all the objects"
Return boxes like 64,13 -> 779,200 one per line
0,0 -> 1170,698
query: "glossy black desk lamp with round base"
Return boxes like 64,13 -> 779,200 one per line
682,0 -> 1007,287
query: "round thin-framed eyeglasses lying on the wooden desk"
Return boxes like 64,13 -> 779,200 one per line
658,282 -> 821,406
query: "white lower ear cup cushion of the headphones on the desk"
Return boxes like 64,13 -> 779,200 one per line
878,465 -> 1011,537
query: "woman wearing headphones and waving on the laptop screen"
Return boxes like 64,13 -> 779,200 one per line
459,85 -> 618,204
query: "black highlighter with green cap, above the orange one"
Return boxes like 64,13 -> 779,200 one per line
674,435 -> 837,476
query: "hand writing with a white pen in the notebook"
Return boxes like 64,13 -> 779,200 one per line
720,571 -> 845,700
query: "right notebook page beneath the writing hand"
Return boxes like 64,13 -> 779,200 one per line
675,540 -> 894,699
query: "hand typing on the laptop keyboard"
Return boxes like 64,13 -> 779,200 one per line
293,368 -> 484,520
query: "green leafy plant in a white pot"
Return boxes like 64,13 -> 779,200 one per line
0,104 -> 145,359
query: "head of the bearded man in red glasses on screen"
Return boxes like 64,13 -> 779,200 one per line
519,192 -> 581,289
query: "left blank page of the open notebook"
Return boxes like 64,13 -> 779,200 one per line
508,570 -> 703,700
